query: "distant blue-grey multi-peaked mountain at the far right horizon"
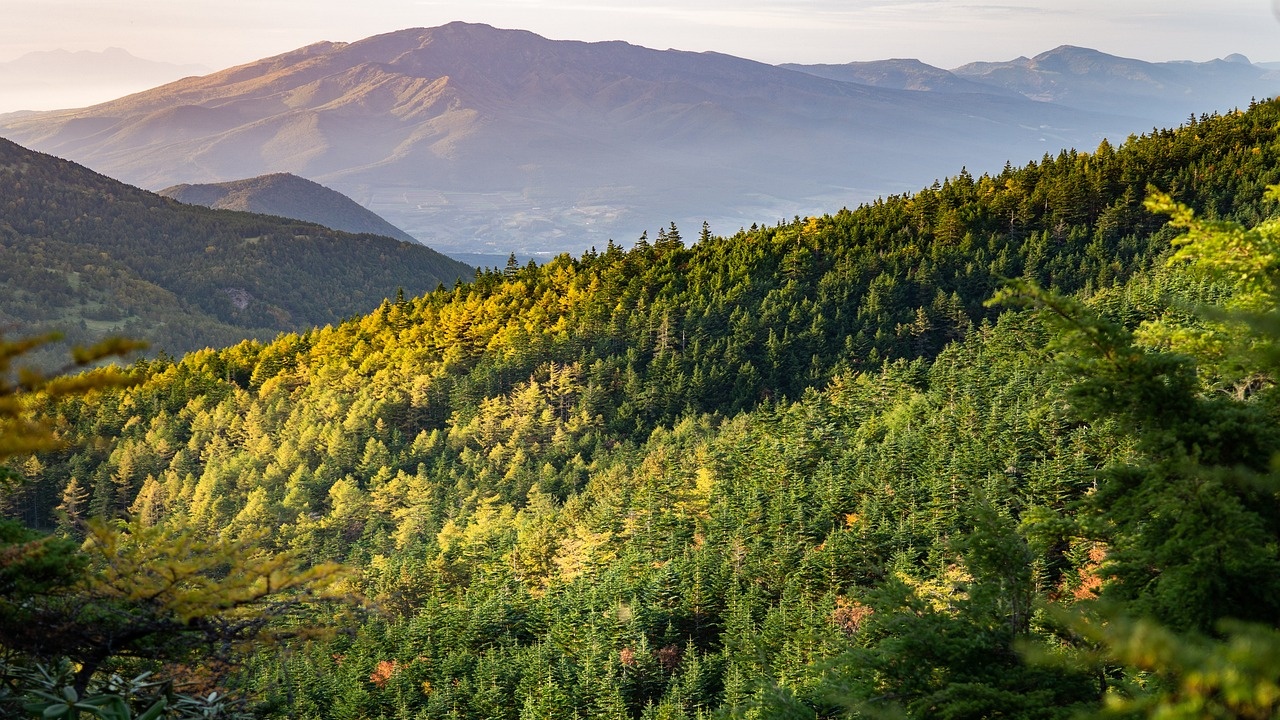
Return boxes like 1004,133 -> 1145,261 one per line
951,45 -> 1280,119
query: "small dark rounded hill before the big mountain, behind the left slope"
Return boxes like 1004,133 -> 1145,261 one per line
160,173 -> 417,242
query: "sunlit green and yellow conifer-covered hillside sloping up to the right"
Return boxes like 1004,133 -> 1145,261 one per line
8,102 -> 1280,720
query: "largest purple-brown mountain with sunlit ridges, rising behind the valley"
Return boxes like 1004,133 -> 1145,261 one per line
0,23 -> 1146,255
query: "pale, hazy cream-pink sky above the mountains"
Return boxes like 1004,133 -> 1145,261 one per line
0,0 -> 1280,68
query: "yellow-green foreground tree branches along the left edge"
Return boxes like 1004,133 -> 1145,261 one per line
0,337 -> 347,717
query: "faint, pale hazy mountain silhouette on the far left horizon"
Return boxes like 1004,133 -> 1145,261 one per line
0,47 -> 210,113
